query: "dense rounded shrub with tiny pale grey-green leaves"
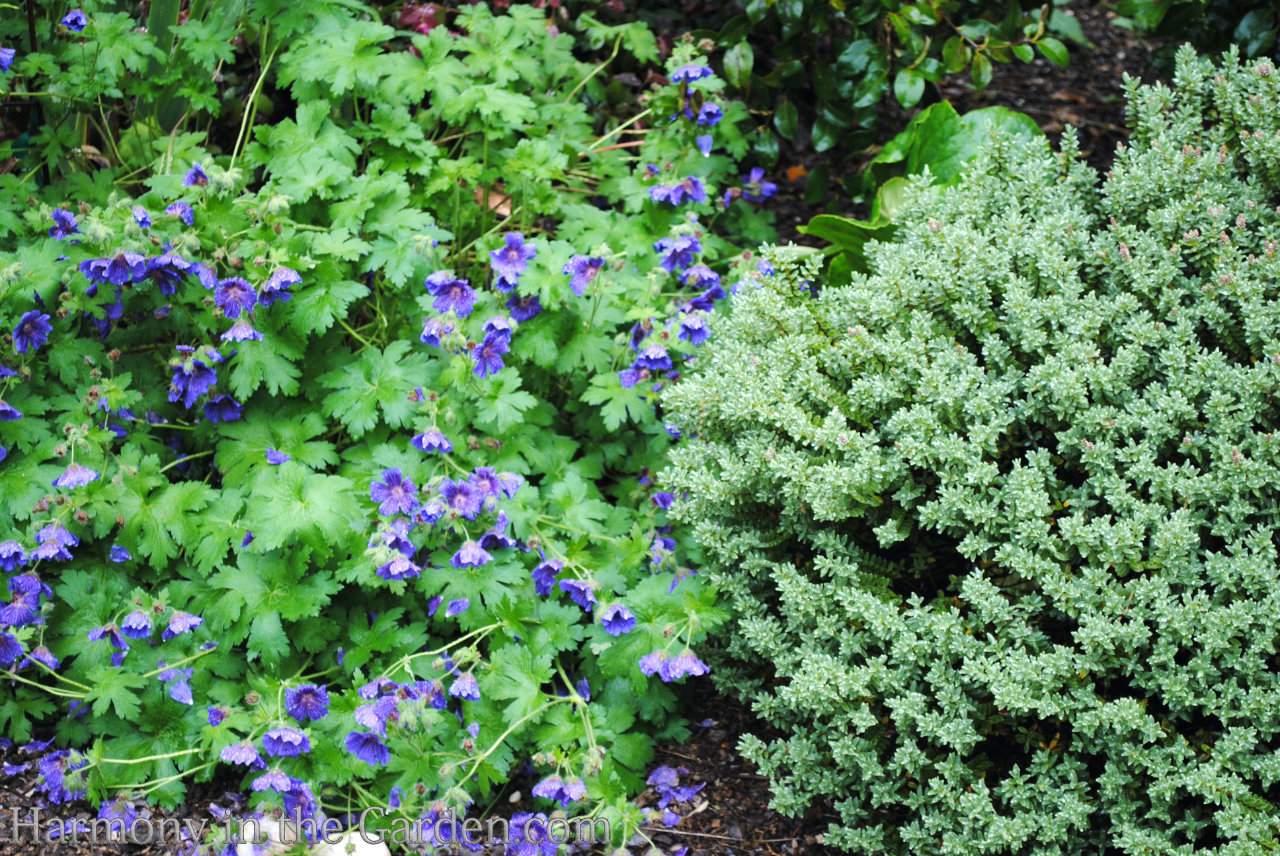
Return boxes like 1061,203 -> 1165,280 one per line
663,49 -> 1280,856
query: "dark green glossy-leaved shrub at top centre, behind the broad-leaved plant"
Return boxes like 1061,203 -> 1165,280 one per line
589,0 -> 1083,165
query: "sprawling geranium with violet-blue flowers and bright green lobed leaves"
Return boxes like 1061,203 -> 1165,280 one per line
0,0 -> 798,843
